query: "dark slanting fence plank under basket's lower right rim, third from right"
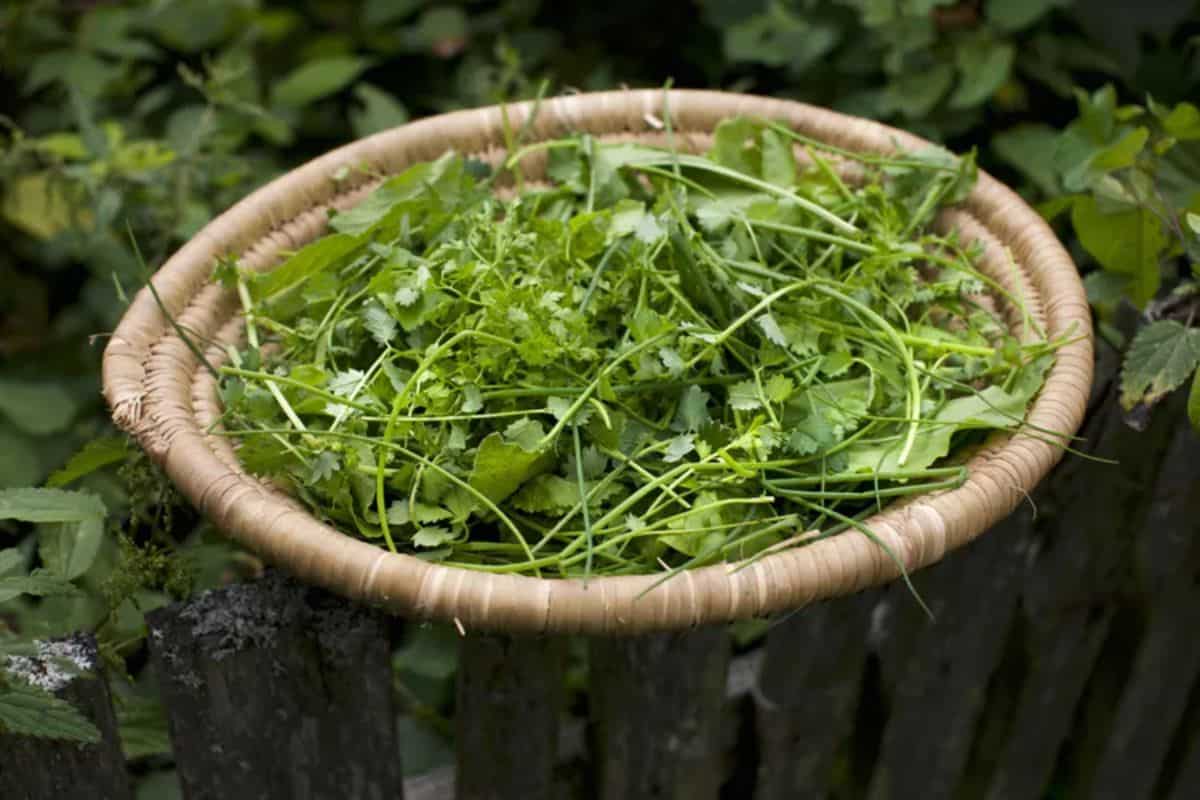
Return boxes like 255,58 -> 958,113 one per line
869,516 -> 1028,800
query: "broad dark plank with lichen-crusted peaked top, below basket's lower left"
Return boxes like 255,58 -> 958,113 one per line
146,575 -> 402,800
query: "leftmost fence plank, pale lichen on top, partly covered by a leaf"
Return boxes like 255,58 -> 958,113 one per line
0,634 -> 132,800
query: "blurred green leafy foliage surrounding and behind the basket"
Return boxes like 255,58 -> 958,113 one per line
0,0 -> 1200,786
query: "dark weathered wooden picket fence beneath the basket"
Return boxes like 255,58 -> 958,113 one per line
0,352 -> 1200,800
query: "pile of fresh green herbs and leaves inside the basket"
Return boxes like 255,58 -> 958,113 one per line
217,118 -> 1052,576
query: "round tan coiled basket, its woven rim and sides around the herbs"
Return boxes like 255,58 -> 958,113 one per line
103,90 -> 1092,634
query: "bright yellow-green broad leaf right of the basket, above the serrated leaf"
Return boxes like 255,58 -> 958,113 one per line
1070,197 -> 1169,308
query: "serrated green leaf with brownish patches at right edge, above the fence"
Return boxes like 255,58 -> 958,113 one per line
1121,319 -> 1200,409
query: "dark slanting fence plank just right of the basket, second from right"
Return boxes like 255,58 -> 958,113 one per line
988,353 -> 1171,800
